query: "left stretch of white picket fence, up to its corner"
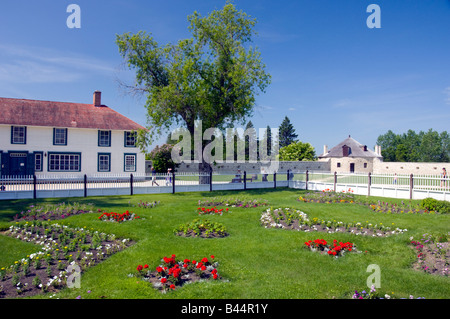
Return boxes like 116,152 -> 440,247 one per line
0,172 -> 288,200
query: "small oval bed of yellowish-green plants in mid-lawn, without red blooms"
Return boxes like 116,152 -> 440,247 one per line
174,219 -> 228,238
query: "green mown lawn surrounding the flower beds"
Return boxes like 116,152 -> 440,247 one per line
0,188 -> 450,299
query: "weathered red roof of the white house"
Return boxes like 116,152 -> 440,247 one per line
0,98 -> 145,131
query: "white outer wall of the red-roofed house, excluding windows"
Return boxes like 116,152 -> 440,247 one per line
0,125 -> 145,175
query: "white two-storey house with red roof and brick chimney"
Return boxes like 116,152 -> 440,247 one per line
0,91 -> 145,176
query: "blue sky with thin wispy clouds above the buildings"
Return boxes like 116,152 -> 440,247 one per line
0,0 -> 450,154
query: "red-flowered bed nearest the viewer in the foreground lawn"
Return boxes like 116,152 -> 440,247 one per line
136,255 -> 221,293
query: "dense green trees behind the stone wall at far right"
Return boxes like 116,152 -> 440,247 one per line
377,129 -> 450,162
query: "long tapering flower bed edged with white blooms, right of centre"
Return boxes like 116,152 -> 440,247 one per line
260,208 -> 407,237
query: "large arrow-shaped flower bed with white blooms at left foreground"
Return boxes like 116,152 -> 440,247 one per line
0,221 -> 132,298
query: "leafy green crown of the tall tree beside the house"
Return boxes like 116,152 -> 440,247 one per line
116,3 -> 270,174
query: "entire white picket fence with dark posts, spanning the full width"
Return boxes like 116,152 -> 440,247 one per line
0,171 -> 450,200
